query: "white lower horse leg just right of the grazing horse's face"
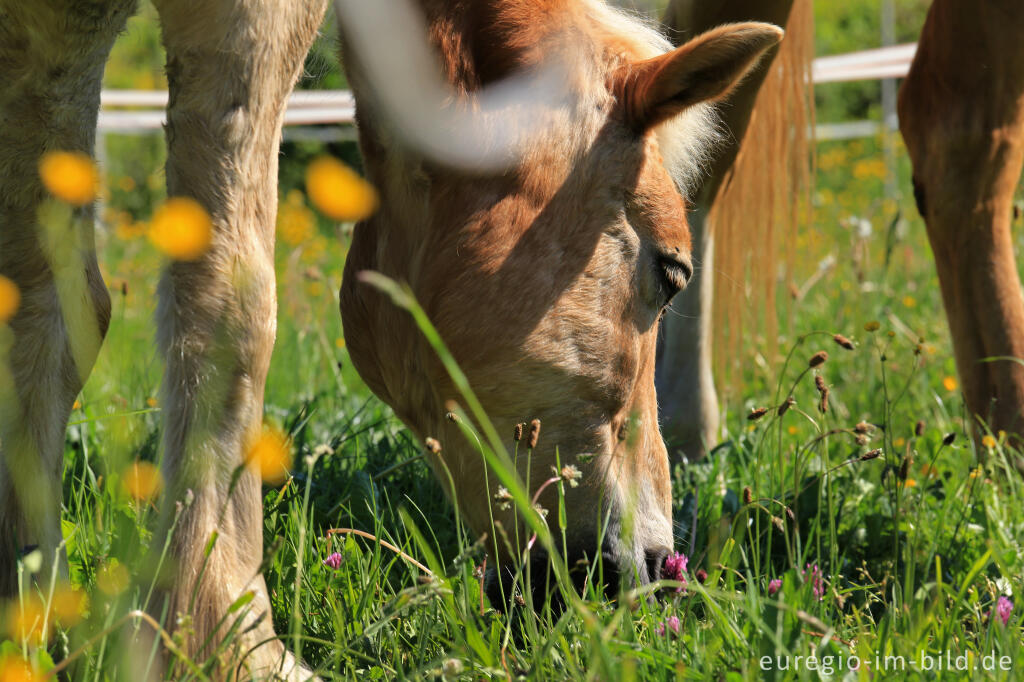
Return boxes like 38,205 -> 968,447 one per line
655,208 -> 719,461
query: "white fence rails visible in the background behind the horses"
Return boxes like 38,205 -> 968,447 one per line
98,43 -> 916,139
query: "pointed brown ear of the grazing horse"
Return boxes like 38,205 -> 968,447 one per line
615,22 -> 783,131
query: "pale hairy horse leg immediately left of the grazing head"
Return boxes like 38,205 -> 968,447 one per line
147,0 -> 326,675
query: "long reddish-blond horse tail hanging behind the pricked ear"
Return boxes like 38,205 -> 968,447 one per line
709,0 -> 814,387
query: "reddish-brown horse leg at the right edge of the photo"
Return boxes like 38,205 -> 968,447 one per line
898,0 -> 1024,437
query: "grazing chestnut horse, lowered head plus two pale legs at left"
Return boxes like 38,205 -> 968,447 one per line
0,0 -> 781,674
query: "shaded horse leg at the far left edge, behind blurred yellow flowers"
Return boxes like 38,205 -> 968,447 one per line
0,0 -> 135,597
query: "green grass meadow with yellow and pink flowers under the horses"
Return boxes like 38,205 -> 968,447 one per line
0,2 -> 1024,682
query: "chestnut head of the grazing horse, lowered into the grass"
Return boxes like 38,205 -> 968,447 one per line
341,1 -> 781,583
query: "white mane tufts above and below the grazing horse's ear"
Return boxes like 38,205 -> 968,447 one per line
583,0 -> 725,199
